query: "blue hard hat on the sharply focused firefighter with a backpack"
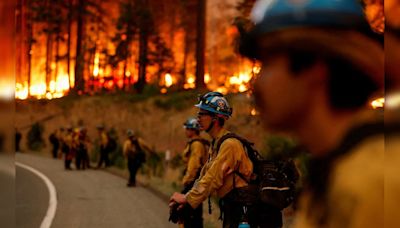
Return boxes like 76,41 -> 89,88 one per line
195,92 -> 232,117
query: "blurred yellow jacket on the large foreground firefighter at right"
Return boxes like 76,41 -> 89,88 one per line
294,135 -> 384,228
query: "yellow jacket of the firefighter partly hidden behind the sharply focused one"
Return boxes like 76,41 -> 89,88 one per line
182,137 -> 208,186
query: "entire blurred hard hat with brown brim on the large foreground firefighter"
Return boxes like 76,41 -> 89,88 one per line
239,0 -> 384,86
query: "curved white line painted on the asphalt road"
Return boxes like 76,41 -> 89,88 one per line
15,162 -> 57,228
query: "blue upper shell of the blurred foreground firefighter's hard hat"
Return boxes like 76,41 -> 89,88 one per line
252,0 -> 368,33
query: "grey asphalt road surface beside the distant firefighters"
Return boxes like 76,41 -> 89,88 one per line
15,154 -> 176,228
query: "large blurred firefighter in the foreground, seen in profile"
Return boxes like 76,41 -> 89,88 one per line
240,0 -> 384,227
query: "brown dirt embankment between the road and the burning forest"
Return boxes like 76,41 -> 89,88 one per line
15,94 -> 264,154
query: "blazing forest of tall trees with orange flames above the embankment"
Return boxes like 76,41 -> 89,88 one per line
16,0 -> 268,99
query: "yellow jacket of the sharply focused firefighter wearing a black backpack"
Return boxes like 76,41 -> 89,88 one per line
186,129 -> 253,208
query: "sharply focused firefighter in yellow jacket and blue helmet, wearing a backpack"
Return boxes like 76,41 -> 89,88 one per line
169,92 -> 253,228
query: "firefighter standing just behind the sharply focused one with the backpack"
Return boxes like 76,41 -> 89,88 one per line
182,118 -> 210,228
